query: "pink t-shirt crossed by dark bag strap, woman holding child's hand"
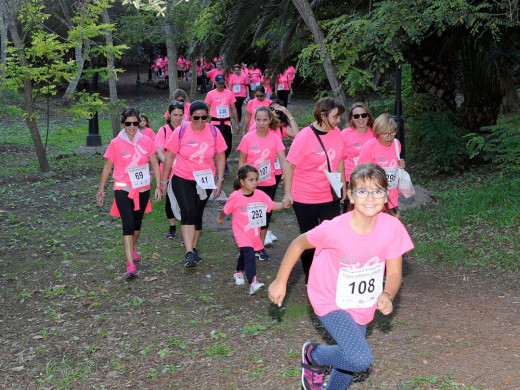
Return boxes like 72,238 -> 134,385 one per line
287,126 -> 343,204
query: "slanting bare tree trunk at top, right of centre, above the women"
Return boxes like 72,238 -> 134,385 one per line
292,0 -> 348,117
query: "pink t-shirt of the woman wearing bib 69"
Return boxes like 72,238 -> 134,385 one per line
103,136 -> 157,189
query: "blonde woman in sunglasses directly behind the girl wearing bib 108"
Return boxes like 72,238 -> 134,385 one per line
357,113 -> 405,214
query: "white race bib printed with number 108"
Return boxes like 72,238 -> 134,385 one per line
336,262 -> 385,309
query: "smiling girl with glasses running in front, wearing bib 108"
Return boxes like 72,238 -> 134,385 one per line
269,164 -> 413,390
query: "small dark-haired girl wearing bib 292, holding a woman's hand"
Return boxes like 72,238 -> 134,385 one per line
217,165 -> 283,295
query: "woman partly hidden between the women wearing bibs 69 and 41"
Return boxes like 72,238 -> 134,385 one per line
154,101 -> 189,240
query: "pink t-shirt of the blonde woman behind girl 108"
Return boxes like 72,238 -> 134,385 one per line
358,138 -> 401,209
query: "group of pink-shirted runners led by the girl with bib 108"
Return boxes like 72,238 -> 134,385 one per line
97,78 -> 413,390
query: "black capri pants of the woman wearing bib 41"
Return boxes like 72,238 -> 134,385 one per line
171,175 -> 213,230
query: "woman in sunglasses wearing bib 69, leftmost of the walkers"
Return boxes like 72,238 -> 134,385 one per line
96,108 -> 162,278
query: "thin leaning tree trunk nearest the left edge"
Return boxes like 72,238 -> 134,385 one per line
4,9 -> 51,172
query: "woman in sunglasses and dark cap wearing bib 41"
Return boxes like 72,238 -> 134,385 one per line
161,101 -> 227,267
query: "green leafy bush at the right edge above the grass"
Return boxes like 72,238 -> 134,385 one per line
466,116 -> 520,175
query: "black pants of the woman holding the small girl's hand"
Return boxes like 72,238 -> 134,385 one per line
293,200 -> 340,283
